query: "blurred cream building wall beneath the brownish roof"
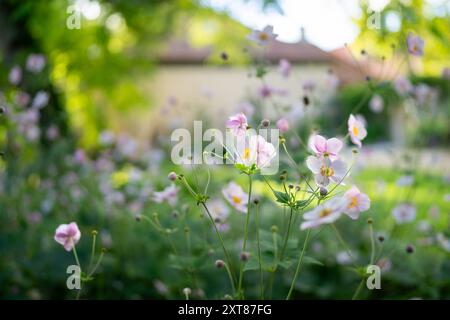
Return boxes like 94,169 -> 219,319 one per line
128,64 -> 329,139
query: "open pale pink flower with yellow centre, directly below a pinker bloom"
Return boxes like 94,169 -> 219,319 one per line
306,156 -> 347,187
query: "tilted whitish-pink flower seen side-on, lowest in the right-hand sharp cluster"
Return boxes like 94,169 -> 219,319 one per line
300,198 -> 347,230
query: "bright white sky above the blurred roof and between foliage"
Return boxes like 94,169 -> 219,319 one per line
203,0 -> 450,50
